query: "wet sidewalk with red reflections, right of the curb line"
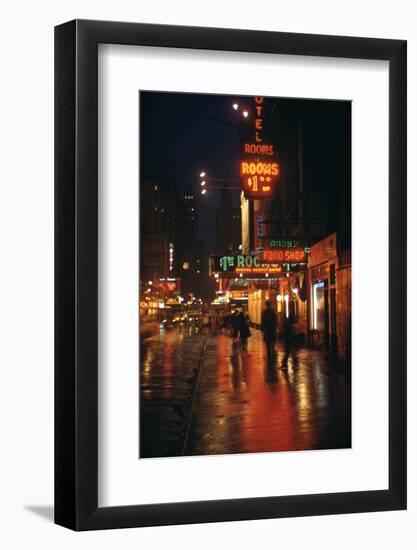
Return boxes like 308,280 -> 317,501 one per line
186,330 -> 351,455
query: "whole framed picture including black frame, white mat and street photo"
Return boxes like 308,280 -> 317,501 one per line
55,20 -> 407,530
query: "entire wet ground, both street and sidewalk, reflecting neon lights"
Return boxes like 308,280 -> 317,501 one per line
140,328 -> 351,458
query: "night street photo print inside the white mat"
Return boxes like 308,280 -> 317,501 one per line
139,91 -> 351,459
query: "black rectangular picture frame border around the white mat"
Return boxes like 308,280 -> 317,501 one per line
55,20 -> 407,531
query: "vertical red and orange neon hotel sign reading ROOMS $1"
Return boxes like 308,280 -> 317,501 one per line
240,97 -> 280,199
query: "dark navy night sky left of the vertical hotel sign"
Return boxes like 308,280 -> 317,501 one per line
140,92 -> 250,252
